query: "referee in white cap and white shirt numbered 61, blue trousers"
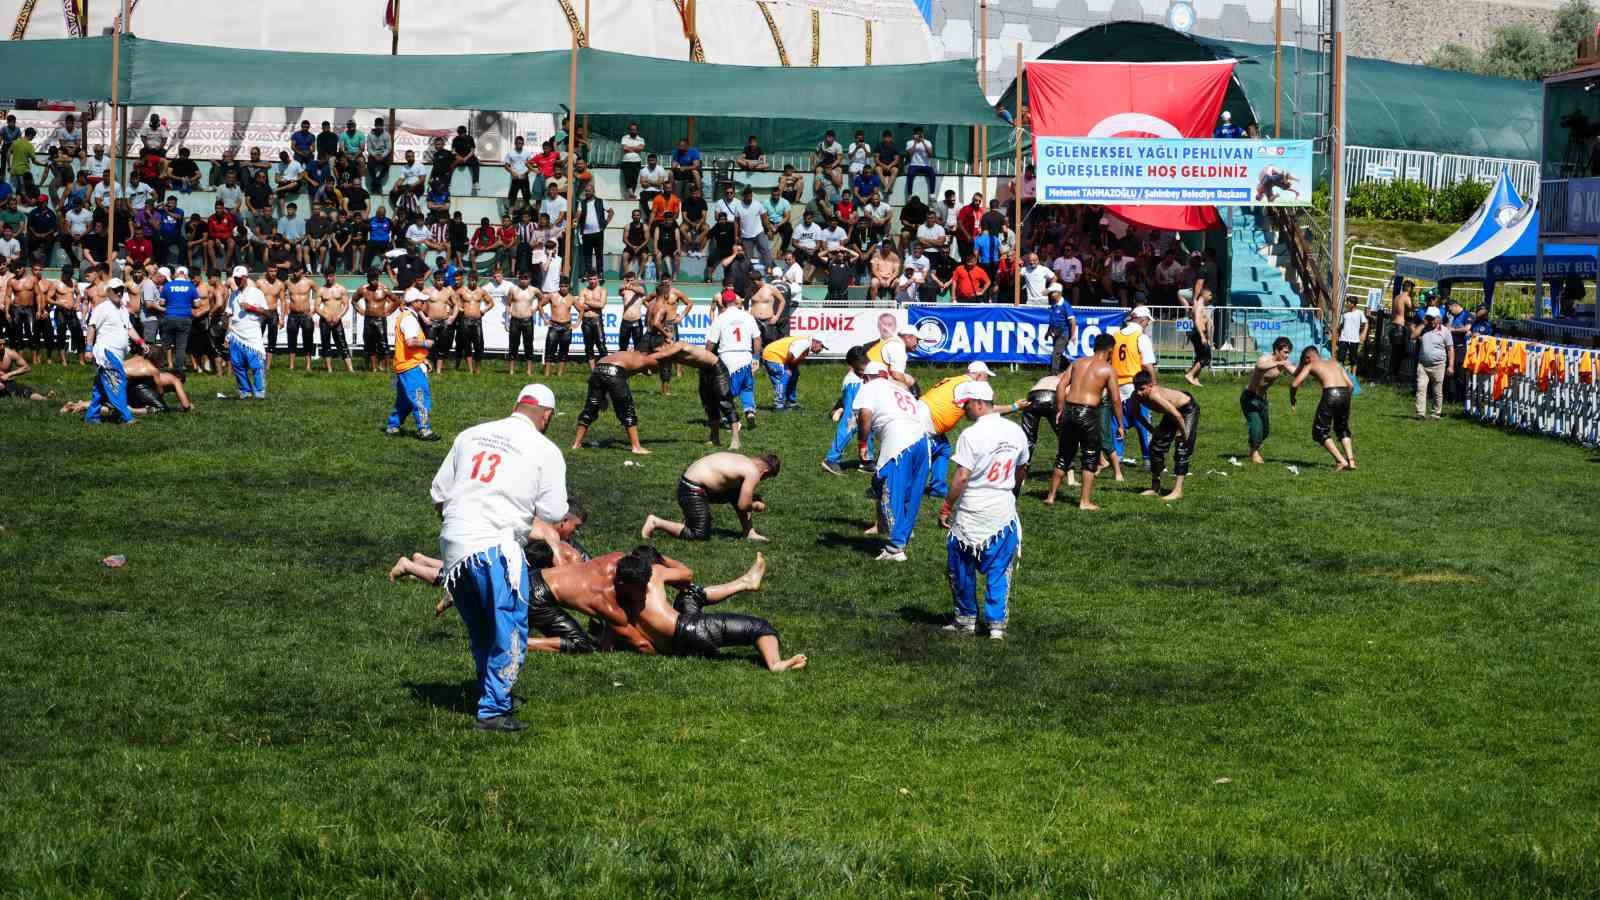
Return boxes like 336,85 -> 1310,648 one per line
939,381 -> 1029,641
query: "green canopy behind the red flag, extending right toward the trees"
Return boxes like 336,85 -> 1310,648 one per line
989,22 -> 1542,160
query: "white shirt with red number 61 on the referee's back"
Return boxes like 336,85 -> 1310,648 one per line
950,412 -> 1029,548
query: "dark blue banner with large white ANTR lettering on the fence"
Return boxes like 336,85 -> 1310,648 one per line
906,304 -> 1128,365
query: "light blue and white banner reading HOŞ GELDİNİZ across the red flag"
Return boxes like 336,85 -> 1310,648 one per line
1037,138 -> 1312,207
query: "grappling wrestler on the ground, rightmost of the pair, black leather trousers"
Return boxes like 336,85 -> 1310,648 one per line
606,544 -> 806,673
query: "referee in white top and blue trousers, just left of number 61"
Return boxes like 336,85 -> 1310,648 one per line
854,362 -> 930,562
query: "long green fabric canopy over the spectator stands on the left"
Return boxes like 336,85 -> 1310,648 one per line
0,35 -> 997,157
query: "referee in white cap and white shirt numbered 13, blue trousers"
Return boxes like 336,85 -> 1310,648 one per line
429,377 -> 568,732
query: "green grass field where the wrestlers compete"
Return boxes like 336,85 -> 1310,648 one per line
0,353 -> 1600,898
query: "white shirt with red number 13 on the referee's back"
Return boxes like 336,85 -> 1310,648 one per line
430,415 -> 566,572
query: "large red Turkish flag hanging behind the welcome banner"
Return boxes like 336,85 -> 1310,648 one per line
1027,59 -> 1234,231
